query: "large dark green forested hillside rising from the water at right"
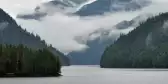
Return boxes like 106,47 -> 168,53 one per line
100,13 -> 168,68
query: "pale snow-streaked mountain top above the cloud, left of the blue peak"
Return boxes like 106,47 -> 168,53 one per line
17,0 -> 87,20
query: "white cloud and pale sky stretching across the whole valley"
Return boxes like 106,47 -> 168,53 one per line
0,0 -> 168,53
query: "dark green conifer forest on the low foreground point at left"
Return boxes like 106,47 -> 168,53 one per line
0,44 -> 61,77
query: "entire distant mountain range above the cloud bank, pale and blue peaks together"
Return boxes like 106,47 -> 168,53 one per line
17,0 -> 151,20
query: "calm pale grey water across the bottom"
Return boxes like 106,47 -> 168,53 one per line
0,66 -> 168,84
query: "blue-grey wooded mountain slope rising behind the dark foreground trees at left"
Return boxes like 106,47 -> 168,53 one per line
0,9 -> 69,65
